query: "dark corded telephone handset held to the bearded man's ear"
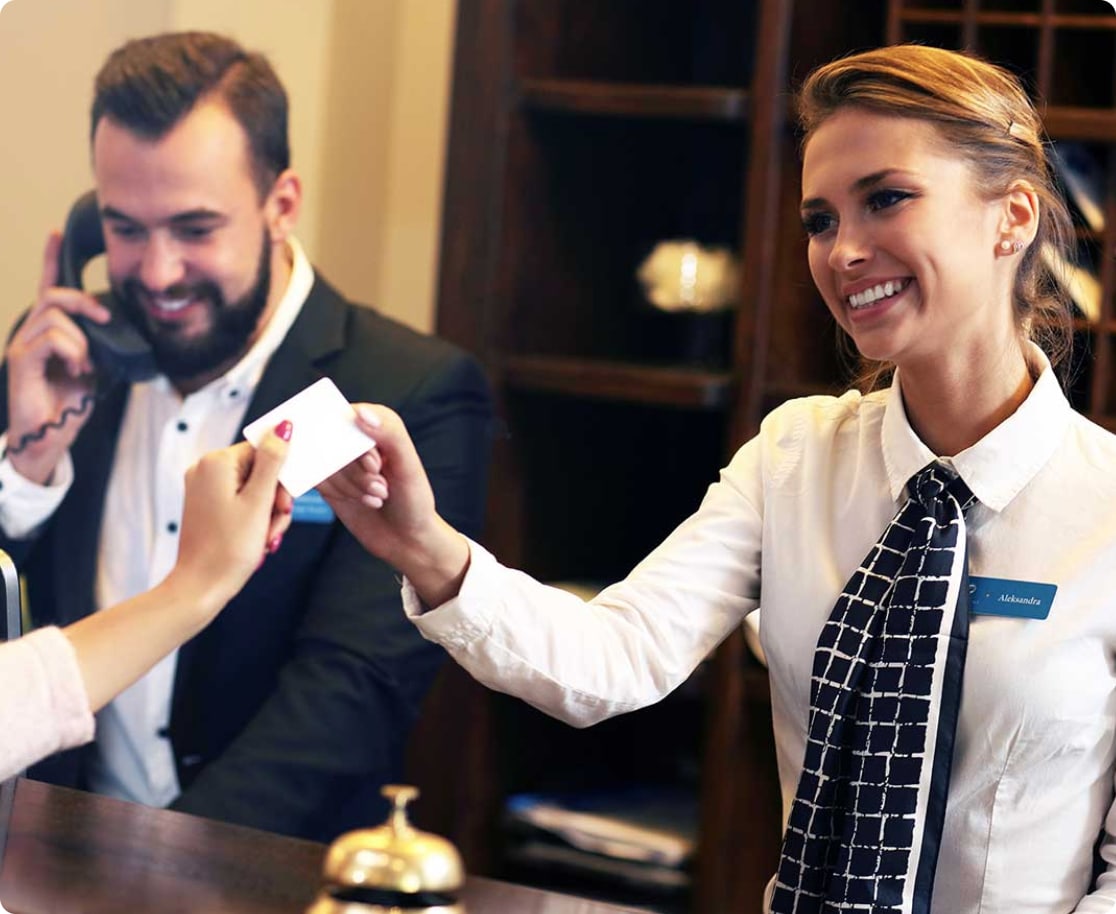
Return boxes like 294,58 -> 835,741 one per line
58,191 -> 158,384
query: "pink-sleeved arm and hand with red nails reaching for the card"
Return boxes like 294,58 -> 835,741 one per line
0,422 -> 291,779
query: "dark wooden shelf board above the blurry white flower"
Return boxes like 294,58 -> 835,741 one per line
519,79 -> 749,123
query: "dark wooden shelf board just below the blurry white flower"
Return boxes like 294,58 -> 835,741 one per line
501,355 -> 734,410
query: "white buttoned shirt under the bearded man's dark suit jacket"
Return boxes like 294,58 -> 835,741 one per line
0,239 -> 314,806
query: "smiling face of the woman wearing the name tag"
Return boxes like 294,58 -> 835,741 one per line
801,107 -> 1017,369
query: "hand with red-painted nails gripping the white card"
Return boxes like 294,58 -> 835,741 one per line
171,422 -> 292,612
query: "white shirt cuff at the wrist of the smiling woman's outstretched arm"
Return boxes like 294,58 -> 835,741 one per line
403,537 -> 491,648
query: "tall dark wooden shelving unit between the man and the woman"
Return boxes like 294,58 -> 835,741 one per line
411,0 -> 885,912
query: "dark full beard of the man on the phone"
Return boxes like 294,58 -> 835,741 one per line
112,232 -> 271,382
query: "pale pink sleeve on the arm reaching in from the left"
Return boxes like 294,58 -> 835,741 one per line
0,627 -> 94,779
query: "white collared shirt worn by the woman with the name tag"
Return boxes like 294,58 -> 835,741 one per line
404,349 -> 1116,914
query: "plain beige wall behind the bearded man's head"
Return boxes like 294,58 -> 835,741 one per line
0,0 -> 454,339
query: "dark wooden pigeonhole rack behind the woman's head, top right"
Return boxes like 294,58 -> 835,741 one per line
887,0 -> 1116,430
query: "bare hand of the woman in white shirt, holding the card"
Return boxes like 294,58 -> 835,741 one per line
318,403 -> 469,606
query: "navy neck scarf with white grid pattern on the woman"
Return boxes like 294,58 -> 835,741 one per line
771,462 -> 975,914
